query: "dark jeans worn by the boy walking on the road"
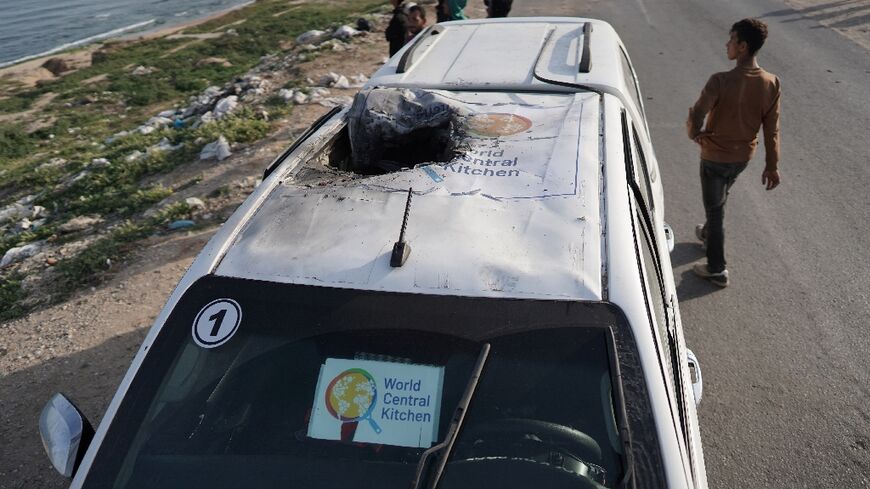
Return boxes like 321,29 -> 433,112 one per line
701,159 -> 749,273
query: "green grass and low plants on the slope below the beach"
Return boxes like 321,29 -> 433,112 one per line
0,0 -> 385,321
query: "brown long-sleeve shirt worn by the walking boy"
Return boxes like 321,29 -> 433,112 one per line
686,66 -> 781,170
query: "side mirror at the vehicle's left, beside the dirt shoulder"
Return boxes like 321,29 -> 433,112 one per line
39,393 -> 94,478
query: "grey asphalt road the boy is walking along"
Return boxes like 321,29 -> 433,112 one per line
511,0 -> 870,489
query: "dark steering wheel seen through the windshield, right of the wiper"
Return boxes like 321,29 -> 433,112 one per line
457,418 -> 605,483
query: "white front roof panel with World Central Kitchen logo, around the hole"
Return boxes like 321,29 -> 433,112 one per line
214,89 -> 602,300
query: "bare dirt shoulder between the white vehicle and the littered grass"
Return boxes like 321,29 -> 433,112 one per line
0,4 -> 485,489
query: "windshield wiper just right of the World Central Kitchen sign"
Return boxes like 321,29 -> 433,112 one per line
411,343 -> 490,489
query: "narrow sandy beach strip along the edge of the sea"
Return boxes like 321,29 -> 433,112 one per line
0,0 -> 256,90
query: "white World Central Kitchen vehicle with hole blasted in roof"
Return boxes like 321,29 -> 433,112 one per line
40,18 -> 707,489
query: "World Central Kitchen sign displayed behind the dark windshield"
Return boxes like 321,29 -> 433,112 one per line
308,358 -> 444,448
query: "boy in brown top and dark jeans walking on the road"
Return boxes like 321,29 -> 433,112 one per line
686,19 -> 781,287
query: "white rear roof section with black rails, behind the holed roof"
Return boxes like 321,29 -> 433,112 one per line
370,17 -> 625,92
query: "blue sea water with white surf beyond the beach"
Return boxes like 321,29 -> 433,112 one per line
0,0 -> 252,67
